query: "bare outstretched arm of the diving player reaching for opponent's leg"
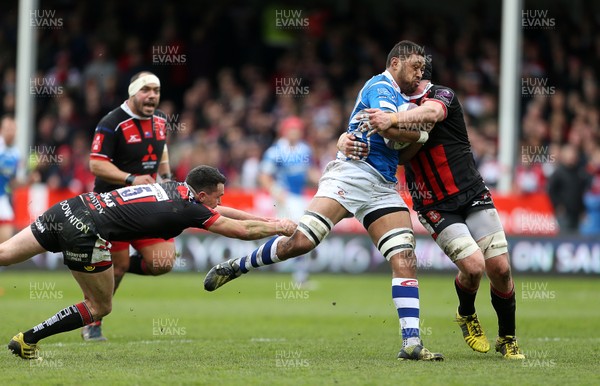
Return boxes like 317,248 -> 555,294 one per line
207,216 -> 297,240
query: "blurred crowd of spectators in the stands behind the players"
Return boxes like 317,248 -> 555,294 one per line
0,0 -> 600,232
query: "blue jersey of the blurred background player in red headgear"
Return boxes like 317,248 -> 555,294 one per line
260,138 -> 312,195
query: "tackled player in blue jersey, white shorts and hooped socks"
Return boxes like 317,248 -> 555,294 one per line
204,40 -> 443,361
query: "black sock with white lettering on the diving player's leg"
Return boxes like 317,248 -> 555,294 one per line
23,303 -> 94,343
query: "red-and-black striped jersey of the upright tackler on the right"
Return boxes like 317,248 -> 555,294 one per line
405,85 -> 483,211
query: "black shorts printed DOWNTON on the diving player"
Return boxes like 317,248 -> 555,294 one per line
31,197 -> 112,273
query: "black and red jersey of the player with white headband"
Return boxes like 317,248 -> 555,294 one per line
90,102 -> 166,193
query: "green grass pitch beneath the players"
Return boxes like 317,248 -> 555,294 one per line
0,271 -> 600,386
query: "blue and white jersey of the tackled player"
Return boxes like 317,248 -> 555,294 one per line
337,70 -> 408,182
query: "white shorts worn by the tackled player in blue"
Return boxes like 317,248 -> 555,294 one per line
315,160 -> 408,223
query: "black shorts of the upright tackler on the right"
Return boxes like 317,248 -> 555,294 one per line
418,185 -> 495,239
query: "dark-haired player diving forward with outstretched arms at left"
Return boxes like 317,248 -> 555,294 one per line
0,166 -> 296,359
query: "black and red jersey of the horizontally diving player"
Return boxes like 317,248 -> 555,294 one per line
79,182 -> 220,241
